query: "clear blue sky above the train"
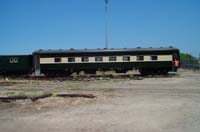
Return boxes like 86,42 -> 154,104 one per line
0,0 -> 200,56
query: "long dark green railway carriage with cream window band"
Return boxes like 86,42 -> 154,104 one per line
33,47 -> 180,76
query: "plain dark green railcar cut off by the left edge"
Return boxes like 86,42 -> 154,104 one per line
0,55 -> 33,75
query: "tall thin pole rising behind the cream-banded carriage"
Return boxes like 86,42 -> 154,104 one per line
105,0 -> 109,49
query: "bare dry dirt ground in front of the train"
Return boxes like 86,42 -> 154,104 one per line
0,70 -> 200,132
